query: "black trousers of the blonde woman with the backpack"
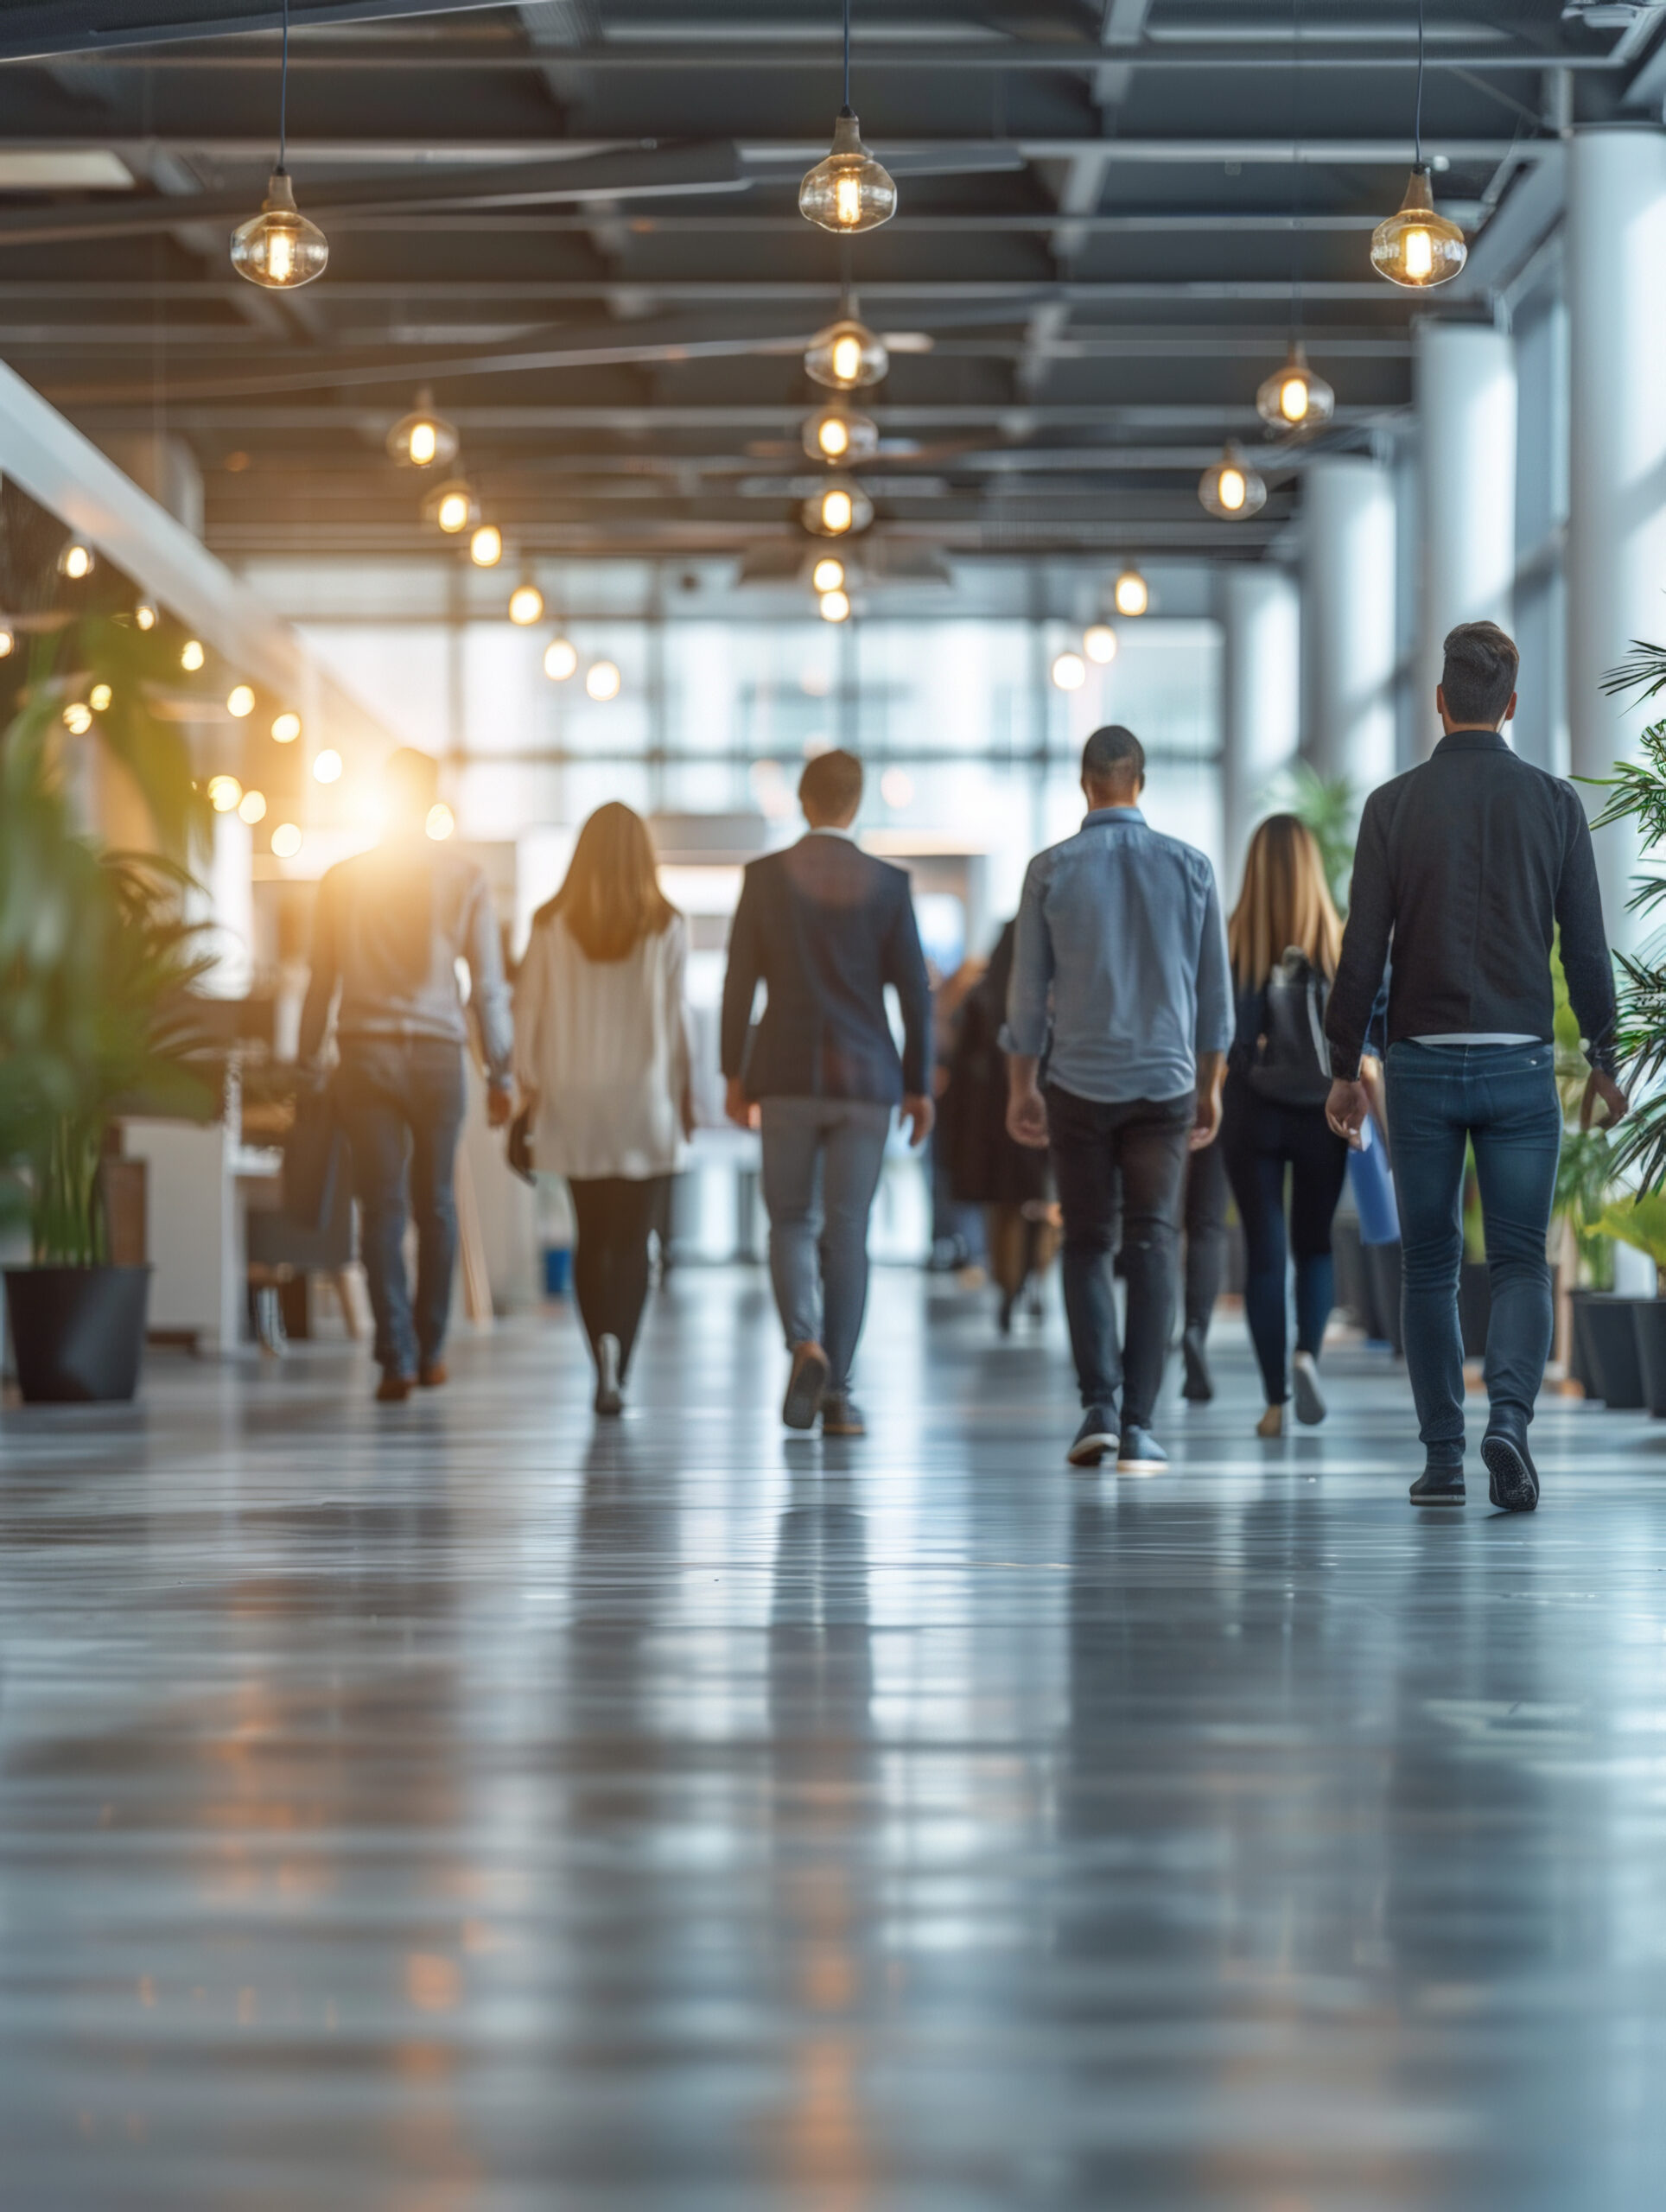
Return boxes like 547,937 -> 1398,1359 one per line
1217,1075 -> 1347,1405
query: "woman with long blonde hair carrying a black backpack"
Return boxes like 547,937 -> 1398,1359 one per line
1221,814 -> 1347,1435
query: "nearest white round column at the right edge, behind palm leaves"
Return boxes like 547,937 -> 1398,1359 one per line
1564,128 -> 1666,943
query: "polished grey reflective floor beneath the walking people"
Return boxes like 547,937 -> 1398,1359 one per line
0,1272 -> 1666,2212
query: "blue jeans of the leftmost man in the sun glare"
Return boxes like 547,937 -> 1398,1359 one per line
334,1038 -> 462,1376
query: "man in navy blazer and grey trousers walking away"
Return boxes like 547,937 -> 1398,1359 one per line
723,752 -> 933,1435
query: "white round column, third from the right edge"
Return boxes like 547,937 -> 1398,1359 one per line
1301,454 -> 1394,798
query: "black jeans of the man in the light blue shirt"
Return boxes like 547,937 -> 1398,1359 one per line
1046,1084 -> 1197,1429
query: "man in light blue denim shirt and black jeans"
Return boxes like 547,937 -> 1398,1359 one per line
1002,723 -> 1232,1473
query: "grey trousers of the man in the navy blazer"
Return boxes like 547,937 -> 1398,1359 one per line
763,1099 -> 892,1389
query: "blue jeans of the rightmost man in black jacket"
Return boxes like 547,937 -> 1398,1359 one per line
1387,1042 -> 1562,1466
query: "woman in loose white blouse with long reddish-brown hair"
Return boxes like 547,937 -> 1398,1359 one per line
516,803 -> 692,1414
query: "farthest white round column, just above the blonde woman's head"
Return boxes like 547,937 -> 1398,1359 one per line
1219,562 -> 1301,905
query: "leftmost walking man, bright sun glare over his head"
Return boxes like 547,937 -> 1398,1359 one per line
299,746 -> 513,1405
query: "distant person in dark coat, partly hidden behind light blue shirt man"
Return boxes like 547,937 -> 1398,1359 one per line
936,923 -> 1058,1336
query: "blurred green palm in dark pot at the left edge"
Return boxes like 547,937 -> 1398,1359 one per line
0,619 -> 213,1400
